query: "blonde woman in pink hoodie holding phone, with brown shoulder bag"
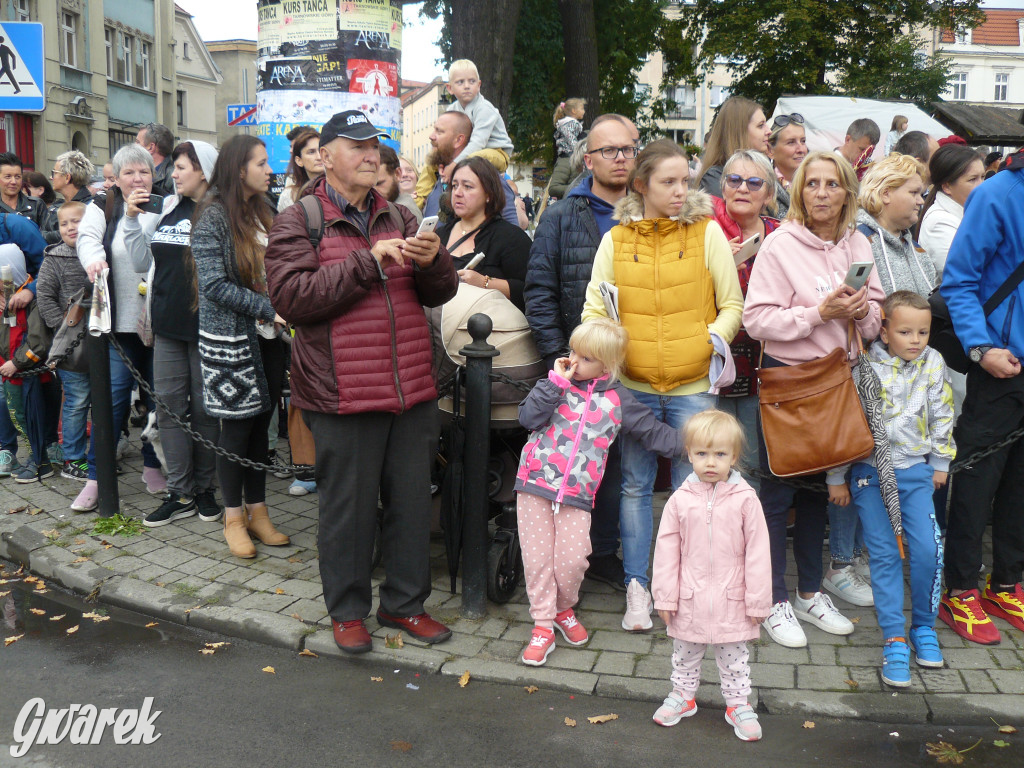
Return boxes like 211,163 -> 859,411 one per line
743,152 -> 885,648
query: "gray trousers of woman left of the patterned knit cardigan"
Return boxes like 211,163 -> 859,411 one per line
153,336 -> 220,497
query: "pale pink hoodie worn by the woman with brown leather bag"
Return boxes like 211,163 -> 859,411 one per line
743,221 -> 886,366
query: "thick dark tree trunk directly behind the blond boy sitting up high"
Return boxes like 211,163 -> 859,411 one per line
452,0 -> 522,117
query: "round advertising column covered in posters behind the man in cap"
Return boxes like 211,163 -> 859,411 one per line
256,0 -> 402,174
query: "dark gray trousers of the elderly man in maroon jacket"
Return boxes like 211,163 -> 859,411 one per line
302,400 -> 438,622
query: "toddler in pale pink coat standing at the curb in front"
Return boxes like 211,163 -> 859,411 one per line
651,410 -> 771,741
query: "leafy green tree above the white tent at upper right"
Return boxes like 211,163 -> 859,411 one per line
686,0 -> 984,113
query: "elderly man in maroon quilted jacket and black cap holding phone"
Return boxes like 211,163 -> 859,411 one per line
266,111 -> 459,653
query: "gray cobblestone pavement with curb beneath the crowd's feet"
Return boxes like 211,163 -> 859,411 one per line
0,432 -> 1024,725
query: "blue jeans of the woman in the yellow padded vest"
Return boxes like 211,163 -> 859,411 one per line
618,392 -> 718,586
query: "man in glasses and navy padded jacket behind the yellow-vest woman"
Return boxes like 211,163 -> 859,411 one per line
525,115 -> 637,591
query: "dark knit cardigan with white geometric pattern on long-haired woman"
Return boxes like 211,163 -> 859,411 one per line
191,198 -> 274,419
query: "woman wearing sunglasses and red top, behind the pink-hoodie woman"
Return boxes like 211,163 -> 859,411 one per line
712,150 -> 778,466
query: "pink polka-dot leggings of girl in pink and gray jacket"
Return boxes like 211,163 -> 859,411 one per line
516,493 -> 591,629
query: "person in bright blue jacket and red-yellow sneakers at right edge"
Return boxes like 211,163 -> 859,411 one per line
939,151 -> 1024,645
